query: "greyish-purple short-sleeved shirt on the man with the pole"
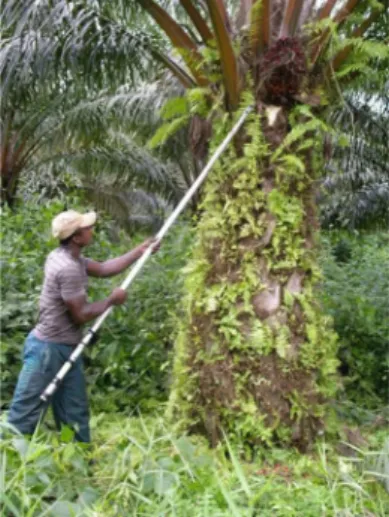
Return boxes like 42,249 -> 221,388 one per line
34,247 -> 88,345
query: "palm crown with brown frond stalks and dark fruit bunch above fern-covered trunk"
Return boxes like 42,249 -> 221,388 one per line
138,0 -> 385,110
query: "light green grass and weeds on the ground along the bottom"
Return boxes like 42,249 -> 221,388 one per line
0,407 -> 389,517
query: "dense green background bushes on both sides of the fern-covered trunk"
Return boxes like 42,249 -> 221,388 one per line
1,196 -> 389,411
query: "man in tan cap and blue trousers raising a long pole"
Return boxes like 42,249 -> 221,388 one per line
8,210 -> 159,442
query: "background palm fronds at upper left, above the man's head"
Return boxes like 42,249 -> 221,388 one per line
0,2 -> 191,220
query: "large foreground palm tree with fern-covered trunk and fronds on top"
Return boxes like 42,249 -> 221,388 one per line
3,0 -> 388,448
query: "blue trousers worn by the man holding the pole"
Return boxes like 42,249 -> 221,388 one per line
8,332 -> 90,442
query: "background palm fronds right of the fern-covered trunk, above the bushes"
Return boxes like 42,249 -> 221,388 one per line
320,92 -> 389,230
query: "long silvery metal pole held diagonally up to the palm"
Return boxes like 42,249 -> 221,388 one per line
40,106 -> 253,402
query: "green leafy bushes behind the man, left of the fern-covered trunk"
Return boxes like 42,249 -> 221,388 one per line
0,199 -> 191,410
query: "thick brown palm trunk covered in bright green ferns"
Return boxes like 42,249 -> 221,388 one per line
170,108 -> 337,449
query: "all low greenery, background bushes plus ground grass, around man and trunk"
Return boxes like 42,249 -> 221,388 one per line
1,198 -> 389,517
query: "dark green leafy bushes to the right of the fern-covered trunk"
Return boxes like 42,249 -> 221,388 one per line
323,232 -> 389,404
